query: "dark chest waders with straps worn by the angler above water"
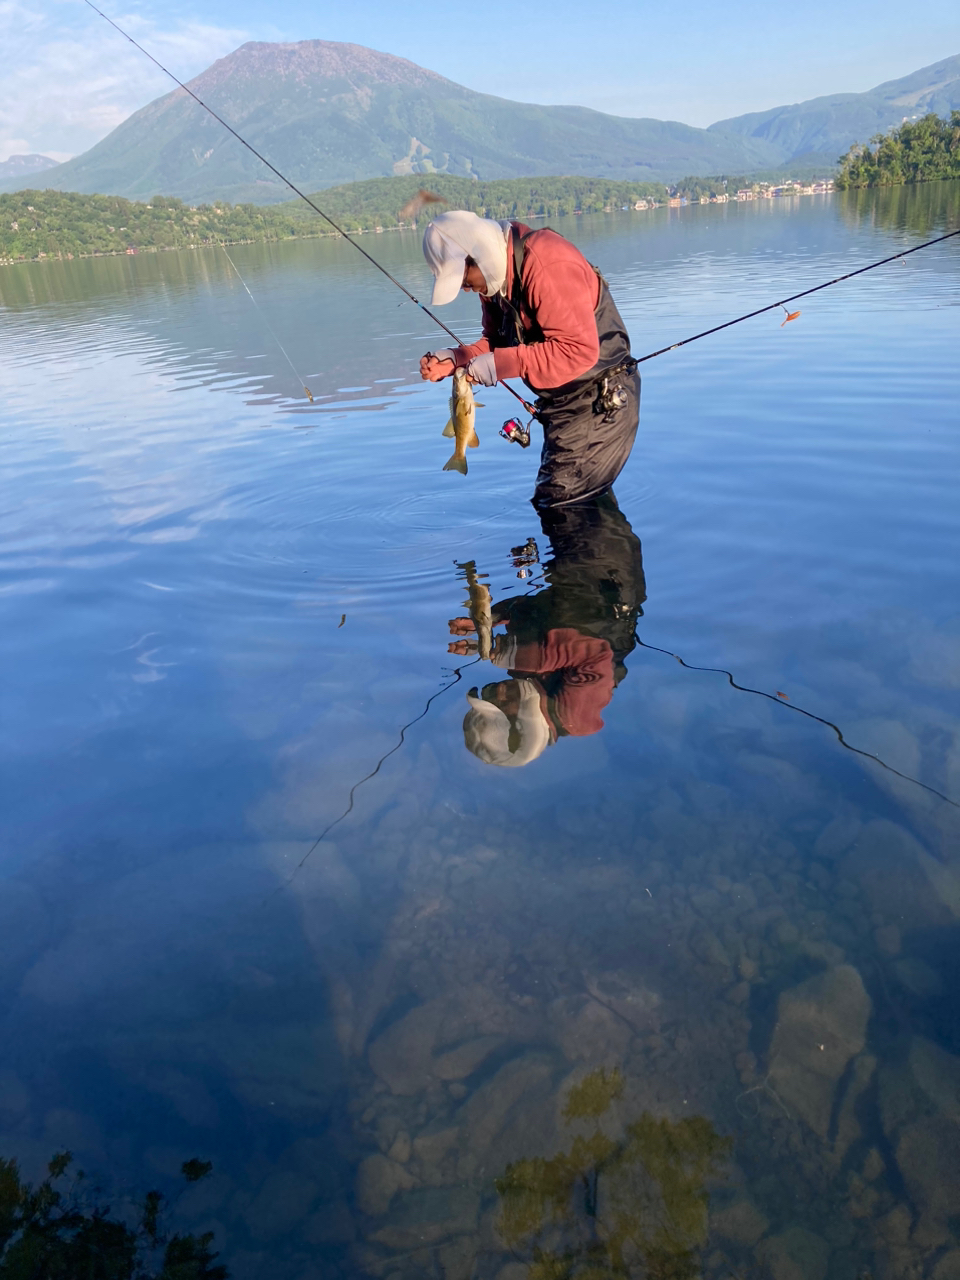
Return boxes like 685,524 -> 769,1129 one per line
497,223 -> 640,508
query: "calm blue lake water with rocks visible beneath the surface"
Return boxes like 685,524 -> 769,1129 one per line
0,183 -> 960,1280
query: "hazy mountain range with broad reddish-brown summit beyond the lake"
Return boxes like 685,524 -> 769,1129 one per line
9,40 -> 960,204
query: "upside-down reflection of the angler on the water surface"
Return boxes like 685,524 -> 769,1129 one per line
452,494 -> 646,767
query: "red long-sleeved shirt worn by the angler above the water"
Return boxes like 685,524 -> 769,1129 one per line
454,223 -> 600,390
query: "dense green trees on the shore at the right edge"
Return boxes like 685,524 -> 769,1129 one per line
836,111 -> 960,188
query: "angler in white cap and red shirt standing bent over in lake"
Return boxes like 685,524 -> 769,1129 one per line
420,210 -> 640,508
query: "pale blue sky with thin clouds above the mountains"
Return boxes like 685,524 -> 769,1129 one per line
0,0 -> 960,160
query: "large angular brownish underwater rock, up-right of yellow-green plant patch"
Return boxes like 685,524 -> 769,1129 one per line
769,965 -> 872,1139
